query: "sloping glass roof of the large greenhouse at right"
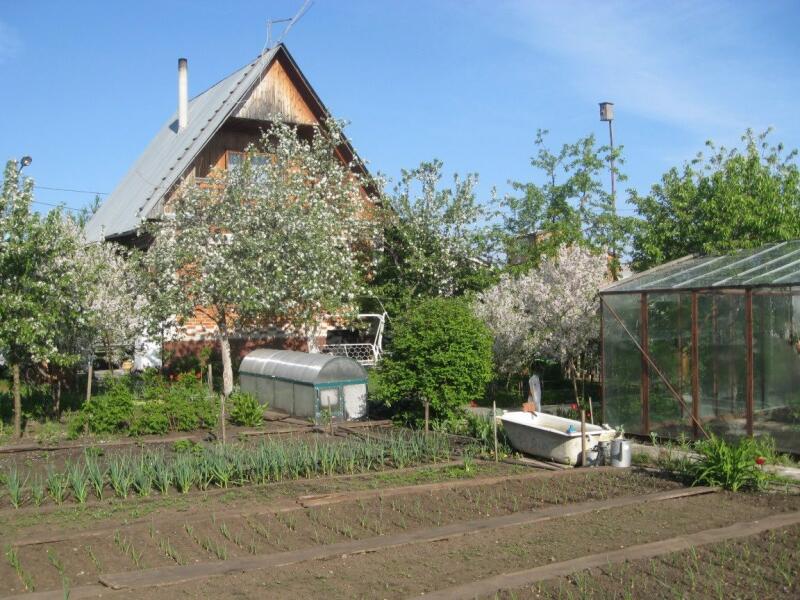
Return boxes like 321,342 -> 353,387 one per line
600,240 -> 800,294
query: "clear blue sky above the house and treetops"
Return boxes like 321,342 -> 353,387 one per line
0,0 -> 800,218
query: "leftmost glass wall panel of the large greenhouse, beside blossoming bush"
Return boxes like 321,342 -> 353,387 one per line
603,294 -> 642,433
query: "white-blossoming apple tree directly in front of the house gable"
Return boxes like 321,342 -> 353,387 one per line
144,117 -> 375,396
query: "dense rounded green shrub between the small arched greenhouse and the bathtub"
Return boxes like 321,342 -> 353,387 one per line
377,298 -> 492,424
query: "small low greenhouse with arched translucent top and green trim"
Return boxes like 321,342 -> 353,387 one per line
239,348 -> 367,423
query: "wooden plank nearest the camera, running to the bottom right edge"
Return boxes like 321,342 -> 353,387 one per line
414,512 -> 800,600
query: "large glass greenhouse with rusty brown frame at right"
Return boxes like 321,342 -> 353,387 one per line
600,240 -> 800,453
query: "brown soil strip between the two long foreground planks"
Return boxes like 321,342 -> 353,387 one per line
95,493 -> 800,598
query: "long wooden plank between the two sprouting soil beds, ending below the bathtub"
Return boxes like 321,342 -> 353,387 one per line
100,487 -> 716,597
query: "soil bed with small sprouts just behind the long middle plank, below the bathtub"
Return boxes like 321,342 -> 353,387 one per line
0,471 -> 675,594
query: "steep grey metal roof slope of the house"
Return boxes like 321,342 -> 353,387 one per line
86,45 -> 285,242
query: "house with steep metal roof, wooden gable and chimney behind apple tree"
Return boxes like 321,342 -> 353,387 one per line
86,44 -> 374,364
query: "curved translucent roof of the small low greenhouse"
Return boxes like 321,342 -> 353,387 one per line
239,348 -> 367,384
